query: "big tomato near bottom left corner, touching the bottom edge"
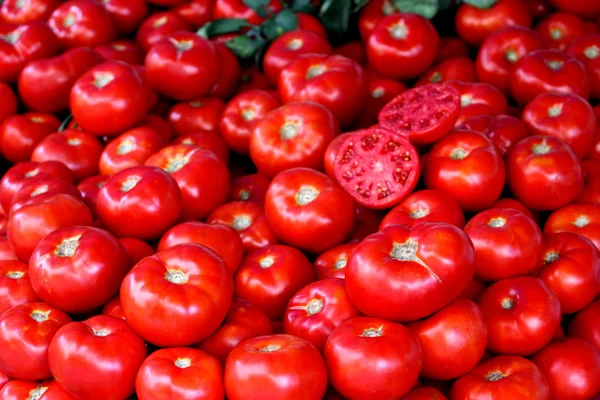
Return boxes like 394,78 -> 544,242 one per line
48,315 -> 148,400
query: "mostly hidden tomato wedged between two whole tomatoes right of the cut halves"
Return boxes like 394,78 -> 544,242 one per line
457,115 -> 529,156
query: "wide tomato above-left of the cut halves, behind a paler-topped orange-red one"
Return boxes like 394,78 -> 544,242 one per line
278,54 -> 367,127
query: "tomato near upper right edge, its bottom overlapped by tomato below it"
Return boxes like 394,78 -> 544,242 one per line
509,50 -> 590,105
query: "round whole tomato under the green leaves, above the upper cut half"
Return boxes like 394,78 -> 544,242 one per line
366,13 -> 440,80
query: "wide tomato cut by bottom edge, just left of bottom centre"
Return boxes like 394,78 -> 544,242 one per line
225,335 -> 327,400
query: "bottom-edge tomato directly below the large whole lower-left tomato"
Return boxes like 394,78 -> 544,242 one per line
135,347 -> 225,400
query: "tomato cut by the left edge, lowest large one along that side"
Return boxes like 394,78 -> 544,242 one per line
0,303 -> 71,381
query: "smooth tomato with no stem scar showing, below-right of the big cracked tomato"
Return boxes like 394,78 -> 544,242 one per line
408,299 -> 487,380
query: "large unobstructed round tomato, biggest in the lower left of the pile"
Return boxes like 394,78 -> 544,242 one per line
120,244 -> 233,347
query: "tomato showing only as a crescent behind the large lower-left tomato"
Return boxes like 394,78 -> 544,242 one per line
158,221 -> 244,275
